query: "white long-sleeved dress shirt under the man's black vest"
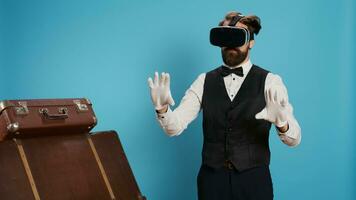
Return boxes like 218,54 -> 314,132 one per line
157,60 -> 301,147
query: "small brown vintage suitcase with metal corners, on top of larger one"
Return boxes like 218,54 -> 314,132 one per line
0,98 -> 97,141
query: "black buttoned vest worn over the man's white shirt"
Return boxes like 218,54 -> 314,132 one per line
202,65 -> 271,170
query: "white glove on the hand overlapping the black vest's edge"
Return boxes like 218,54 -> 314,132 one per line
255,86 -> 288,127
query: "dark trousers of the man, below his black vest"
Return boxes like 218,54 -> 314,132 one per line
197,165 -> 273,200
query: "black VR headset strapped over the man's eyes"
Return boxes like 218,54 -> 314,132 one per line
210,15 -> 253,48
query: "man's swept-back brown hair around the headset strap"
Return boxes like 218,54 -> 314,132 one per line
219,11 -> 262,35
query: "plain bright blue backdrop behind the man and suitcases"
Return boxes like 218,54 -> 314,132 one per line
0,0 -> 356,200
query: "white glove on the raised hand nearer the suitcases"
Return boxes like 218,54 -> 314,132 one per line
148,72 -> 174,110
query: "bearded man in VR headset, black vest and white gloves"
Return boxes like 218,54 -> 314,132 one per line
148,12 -> 301,200
